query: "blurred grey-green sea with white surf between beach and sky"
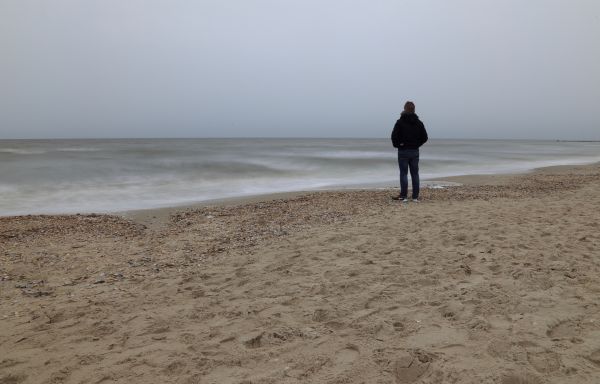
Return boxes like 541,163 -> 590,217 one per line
0,139 -> 600,216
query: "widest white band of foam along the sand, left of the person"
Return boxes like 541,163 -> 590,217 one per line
0,171 -> 398,216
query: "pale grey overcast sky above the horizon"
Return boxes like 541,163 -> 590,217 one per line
0,0 -> 600,139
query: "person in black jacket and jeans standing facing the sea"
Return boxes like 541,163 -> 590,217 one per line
392,101 -> 428,202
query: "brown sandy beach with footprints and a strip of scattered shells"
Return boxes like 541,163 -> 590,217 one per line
0,165 -> 600,384
